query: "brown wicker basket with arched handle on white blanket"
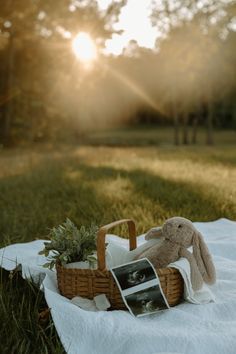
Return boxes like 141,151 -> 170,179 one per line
56,219 -> 184,310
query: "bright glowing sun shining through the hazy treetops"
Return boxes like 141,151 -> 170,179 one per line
72,32 -> 97,64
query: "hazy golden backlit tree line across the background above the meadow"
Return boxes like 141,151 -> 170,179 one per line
0,0 -> 236,145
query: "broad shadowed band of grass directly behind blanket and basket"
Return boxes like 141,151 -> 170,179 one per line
0,158 -> 236,245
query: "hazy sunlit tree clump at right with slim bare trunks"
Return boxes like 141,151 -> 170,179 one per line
149,0 -> 235,144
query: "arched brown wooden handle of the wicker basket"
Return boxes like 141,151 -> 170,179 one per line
97,219 -> 137,270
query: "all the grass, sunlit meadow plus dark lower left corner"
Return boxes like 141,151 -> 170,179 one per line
0,126 -> 236,354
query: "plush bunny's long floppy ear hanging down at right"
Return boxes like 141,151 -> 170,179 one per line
193,231 -> 216,284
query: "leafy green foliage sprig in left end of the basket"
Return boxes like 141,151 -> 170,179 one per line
39,219 -> 98,269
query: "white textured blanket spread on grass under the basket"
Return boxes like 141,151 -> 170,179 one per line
0,219 -> 236,354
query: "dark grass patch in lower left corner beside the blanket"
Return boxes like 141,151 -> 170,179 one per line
0,269 -> 64,354
